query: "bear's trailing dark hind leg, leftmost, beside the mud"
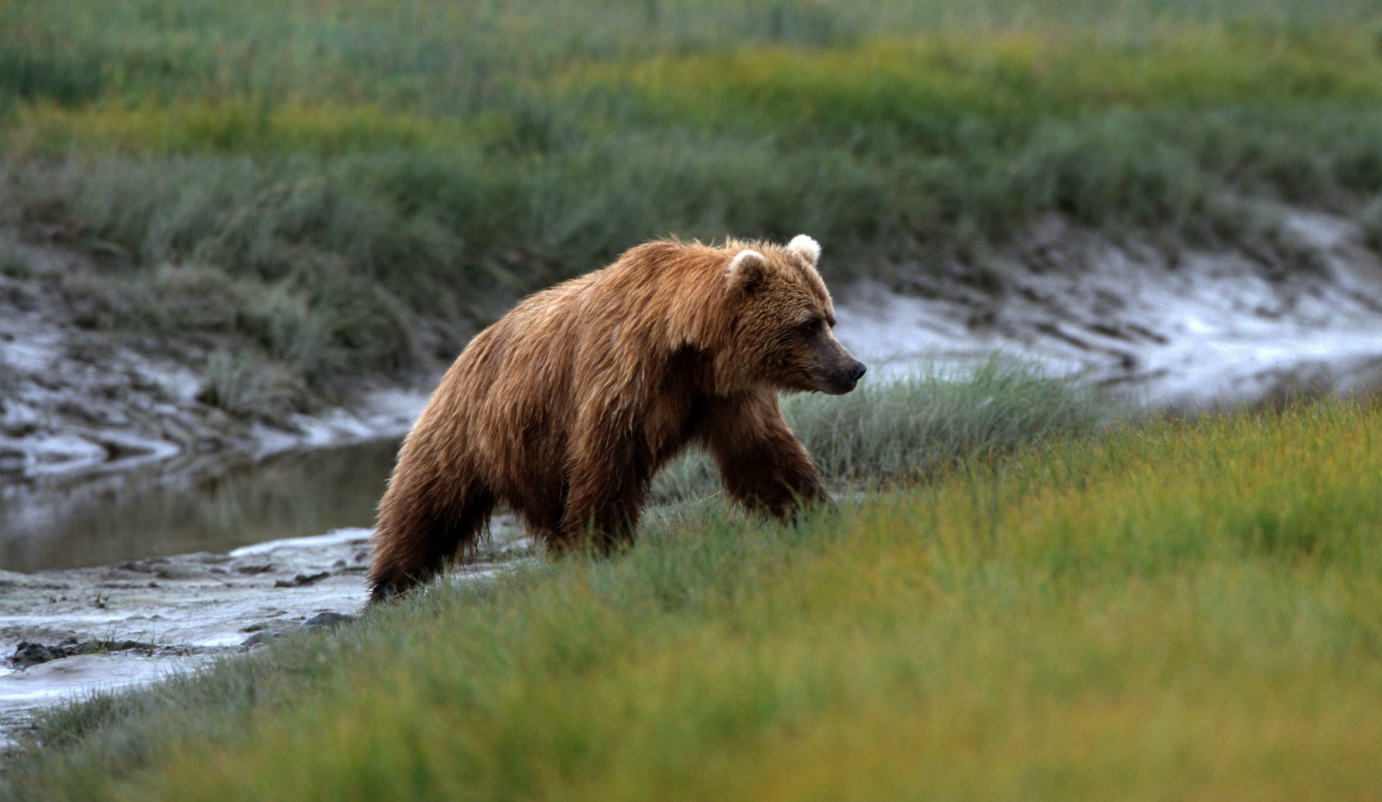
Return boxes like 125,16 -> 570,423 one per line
369,487 -> 495,604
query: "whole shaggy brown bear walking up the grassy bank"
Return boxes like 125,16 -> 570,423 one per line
369,235 -> 864,602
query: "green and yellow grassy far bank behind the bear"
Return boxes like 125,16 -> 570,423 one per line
0,0 -> 1382,411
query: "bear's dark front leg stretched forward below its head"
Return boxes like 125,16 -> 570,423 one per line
705,391 -> 831,520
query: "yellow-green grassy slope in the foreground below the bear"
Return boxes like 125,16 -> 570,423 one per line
7,400 -> 1382,799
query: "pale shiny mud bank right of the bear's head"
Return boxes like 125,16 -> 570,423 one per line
836,212 -> 1382,411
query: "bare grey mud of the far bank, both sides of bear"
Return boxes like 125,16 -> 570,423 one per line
0,206 -> 1382,483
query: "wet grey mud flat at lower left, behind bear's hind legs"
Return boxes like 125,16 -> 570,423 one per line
0,516 -> 528,748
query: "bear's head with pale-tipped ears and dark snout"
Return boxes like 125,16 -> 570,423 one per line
724,234 -> 865,395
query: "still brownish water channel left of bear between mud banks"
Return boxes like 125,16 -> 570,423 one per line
0,441 -> 398,571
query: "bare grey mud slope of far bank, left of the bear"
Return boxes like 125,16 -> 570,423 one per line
0,248 -> 427,483
